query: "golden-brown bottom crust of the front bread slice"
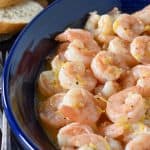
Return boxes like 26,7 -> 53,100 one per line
0,22 -> 26,34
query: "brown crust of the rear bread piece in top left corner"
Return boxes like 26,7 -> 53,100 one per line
0,0 -> 24,8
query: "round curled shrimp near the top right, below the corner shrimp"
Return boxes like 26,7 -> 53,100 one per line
113,14 -> 144,41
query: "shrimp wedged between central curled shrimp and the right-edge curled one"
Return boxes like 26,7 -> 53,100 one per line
108,37 -> 137,67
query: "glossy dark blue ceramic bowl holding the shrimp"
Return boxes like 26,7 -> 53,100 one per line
2,0 -> 150,150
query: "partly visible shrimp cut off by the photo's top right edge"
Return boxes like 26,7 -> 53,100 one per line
133,5 -> 150,25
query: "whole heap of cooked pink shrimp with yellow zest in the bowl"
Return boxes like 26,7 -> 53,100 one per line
38,5 -> 150,150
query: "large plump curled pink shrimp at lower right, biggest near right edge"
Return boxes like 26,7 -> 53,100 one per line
106,87 -> 146,122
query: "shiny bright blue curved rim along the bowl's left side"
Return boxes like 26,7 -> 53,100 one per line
1,0 -> 63,150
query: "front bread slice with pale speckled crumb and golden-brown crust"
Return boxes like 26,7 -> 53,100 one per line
0,0 -> 43,34
